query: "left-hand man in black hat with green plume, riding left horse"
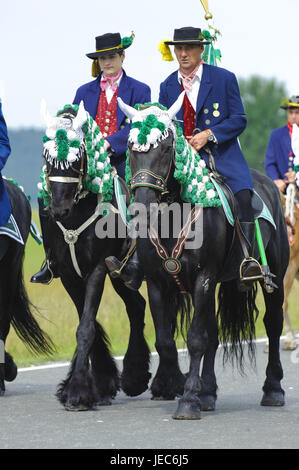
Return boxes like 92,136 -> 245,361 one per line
31,33 -> 151,284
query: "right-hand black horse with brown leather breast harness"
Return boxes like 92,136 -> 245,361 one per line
119,100 -> 288,419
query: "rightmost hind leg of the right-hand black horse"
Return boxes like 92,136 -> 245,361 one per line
261,282 -> 285,406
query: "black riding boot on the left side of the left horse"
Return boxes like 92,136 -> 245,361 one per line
30,199 -> 59,284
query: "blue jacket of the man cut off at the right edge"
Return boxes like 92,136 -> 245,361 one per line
265,126 -> 293,180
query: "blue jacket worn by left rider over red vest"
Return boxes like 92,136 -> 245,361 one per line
73,71 -> 151,177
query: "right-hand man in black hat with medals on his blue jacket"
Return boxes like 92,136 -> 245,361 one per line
159,27 -> 262,288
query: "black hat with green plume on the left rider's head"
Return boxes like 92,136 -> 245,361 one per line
86,33 -> 134,59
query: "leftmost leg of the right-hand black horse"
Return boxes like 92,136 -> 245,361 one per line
147,280 -> 185,400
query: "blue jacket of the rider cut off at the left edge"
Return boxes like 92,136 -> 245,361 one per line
0,101 -> 11,226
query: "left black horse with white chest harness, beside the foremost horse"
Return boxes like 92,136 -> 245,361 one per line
39,105 -> 150,411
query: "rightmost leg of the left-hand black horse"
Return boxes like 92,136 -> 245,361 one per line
111,279 -> 151,397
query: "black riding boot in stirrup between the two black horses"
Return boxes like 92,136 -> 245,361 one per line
105,243 -> 144,290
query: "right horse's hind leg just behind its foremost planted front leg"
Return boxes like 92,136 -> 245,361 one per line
199,302 -> 219,411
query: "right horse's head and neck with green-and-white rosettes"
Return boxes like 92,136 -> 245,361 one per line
118,92 -> 220,207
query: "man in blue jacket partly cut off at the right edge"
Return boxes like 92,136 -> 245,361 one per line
265,96 -> 299,193
